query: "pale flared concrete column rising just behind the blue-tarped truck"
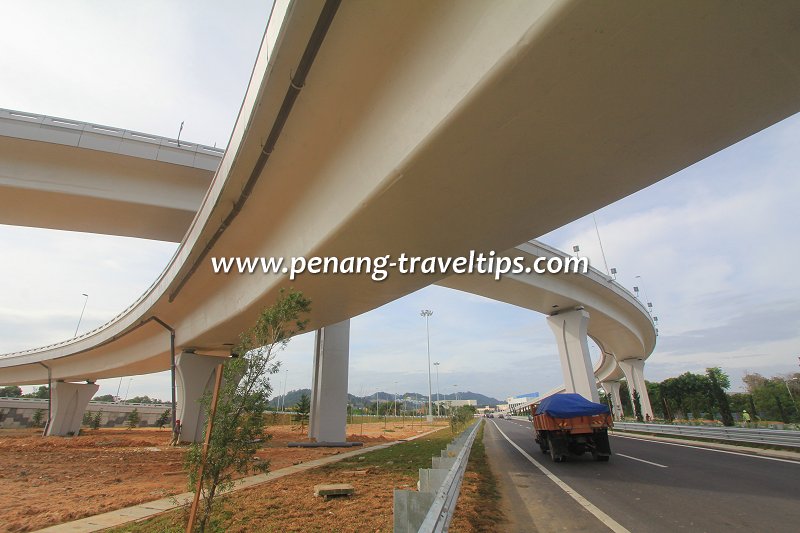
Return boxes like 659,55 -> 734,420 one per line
547,309 -> 600,402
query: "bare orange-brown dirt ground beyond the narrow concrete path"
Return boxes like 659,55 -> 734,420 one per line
0,423 -> 444,532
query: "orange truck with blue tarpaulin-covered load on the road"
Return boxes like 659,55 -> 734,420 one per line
532,393 -> 613,463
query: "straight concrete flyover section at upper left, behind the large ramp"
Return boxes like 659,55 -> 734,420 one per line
0,109 -> 224,242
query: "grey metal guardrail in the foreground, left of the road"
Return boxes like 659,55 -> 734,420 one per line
394,420 -> 481,533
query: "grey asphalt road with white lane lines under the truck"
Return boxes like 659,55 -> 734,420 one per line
484,419 -> 800,532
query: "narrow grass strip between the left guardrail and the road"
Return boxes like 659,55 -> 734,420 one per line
450,422 -> 506,532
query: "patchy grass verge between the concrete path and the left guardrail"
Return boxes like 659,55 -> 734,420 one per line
110,428 -> 456,533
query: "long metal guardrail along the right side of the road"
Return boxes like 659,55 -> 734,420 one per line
614,422 -> 800,448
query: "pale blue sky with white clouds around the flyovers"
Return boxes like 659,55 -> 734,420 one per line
0,0 -> 800,399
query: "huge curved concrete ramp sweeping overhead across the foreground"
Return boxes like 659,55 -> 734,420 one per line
0,2 -> 800,394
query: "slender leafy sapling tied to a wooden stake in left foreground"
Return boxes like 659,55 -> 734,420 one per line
185,291 -> 311,532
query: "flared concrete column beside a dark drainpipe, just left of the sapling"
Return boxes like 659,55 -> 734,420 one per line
175,352 -> 225,442
